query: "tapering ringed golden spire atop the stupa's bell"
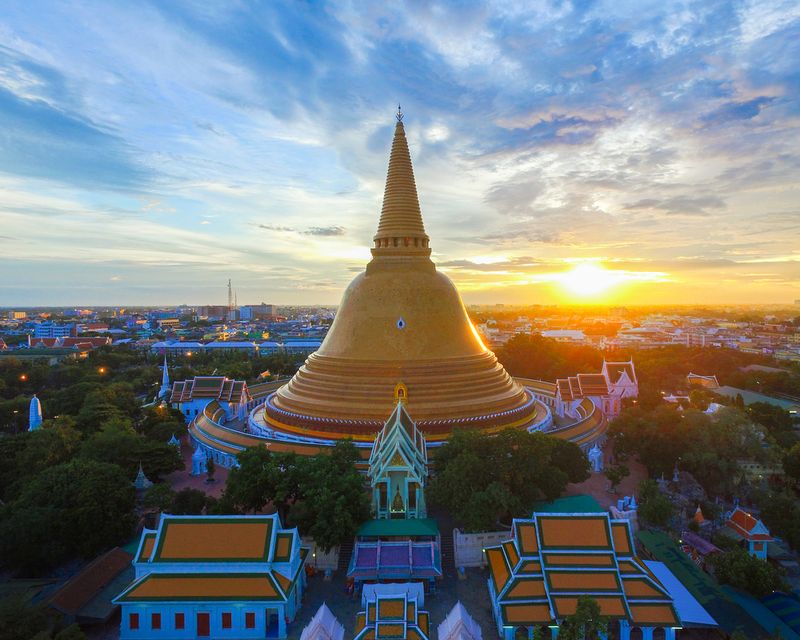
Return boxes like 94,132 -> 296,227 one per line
372,110 -> 431,257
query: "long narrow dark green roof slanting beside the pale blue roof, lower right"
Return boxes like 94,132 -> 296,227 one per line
637,530 -> 764,638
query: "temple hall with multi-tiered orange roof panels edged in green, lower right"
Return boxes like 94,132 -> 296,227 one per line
486,513 -> 681,640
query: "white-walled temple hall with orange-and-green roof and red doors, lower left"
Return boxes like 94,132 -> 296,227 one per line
114,514 -> 307,640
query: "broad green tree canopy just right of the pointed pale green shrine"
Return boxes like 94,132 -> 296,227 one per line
428,429 -> 589,531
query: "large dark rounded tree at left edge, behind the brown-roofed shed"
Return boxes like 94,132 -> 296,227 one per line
0,459 -> 134,572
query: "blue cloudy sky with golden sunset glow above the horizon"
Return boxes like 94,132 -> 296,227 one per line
0,0 -> 800,306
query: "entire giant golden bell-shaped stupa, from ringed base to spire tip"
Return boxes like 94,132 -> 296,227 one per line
264,111 -> 537,436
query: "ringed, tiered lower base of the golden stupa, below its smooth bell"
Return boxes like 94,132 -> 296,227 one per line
264,351 -> 537,436
